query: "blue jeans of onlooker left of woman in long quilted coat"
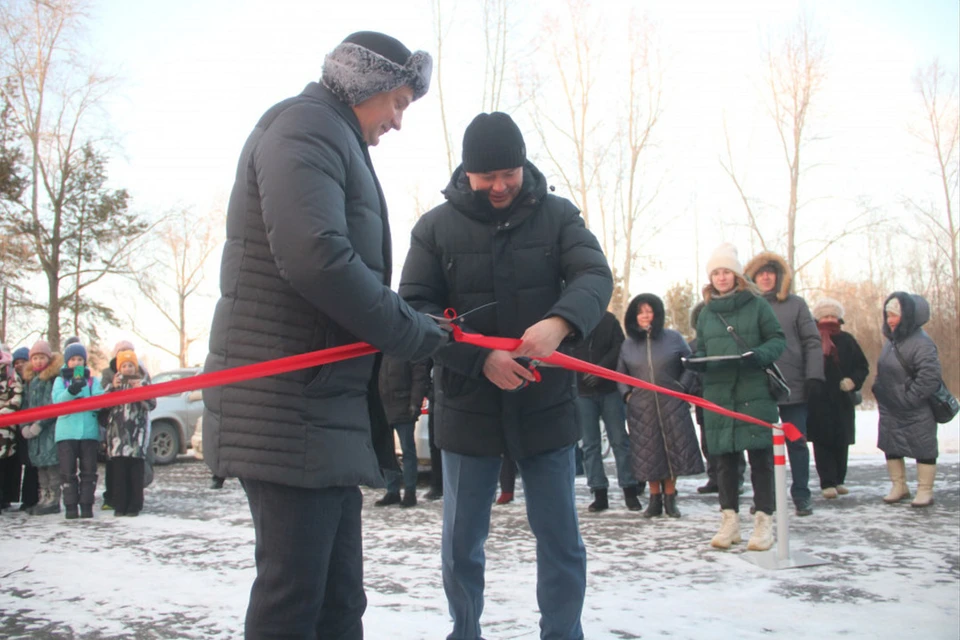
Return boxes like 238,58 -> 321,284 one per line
577,391 -> 637,489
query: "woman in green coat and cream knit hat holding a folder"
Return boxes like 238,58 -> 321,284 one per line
696,243 -> 786,551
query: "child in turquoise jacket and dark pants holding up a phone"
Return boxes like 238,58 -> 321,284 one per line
53,342 -> 103,520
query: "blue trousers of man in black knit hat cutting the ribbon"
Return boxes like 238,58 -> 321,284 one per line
441,446 -> 587,640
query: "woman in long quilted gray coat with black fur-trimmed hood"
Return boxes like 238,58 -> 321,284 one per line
617,293 -> 703,518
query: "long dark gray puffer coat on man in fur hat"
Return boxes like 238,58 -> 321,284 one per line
203,83 -> 445,488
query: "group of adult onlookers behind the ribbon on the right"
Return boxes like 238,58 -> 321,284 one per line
376,244 -> 940,550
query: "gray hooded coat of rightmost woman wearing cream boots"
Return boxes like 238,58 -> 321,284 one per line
873,291 -> 941,460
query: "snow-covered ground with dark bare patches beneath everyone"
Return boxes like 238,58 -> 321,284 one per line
0,411 -> 960,640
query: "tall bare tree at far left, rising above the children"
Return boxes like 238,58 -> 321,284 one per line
0,0 -> 148,348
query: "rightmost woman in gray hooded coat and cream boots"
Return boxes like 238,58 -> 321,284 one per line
873,291 -> 941,507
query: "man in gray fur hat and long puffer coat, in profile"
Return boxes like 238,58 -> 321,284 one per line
203,31 -> 447,639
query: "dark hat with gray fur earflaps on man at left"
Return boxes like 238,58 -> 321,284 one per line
322,31 -> 433,106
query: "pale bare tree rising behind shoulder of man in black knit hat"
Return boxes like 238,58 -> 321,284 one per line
527,0 -> 669,316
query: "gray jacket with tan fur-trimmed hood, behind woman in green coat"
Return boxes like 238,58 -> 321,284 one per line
743,251 -> 824,405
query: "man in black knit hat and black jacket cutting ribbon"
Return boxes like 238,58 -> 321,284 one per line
400,113 -> 613,640
